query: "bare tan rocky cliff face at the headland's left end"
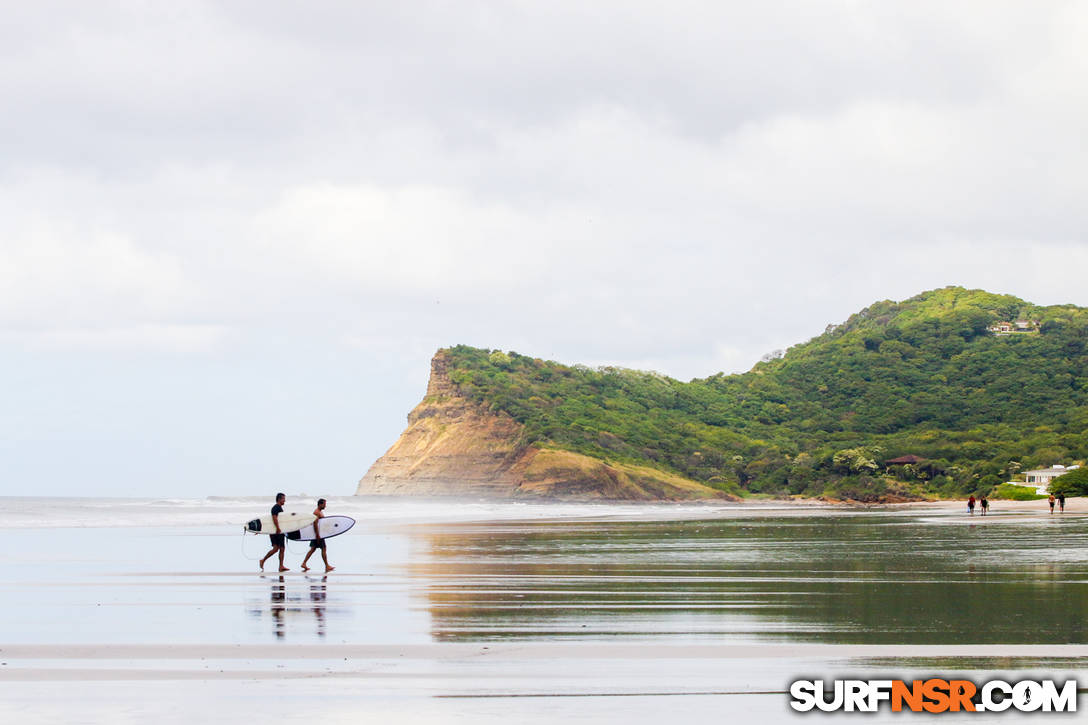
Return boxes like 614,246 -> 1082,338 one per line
356,351 -> 730,501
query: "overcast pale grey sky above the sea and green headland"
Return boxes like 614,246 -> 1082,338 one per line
0,0 -> 1088,496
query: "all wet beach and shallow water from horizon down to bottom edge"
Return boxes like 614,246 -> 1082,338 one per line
0,499 -> 1088,722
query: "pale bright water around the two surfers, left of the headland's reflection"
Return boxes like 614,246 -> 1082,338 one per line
0,496 -> 848,643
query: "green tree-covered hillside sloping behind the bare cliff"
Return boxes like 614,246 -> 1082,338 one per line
446,287 -> 1088,500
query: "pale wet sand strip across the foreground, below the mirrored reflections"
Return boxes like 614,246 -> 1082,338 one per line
0,642 -> 1088,701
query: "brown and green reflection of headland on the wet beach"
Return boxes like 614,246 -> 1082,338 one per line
407,508 -> 1088,647
